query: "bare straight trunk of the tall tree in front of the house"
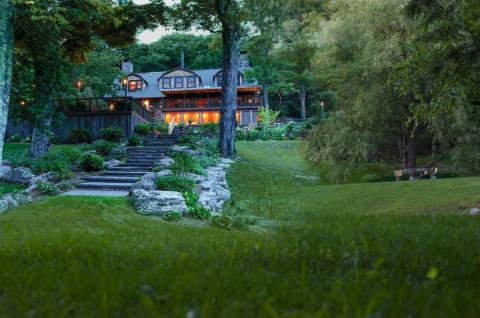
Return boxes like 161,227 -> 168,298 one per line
219,23 -> 240,158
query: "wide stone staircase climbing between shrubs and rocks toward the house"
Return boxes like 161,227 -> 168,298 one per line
65,128 -> 186,196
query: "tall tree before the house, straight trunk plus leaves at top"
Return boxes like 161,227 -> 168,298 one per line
172,0 -> 245,158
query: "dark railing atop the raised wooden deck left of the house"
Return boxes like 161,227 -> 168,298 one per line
54,97 -> 154,121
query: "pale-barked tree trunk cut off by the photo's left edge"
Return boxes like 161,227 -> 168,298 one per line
0,0 -> 13,163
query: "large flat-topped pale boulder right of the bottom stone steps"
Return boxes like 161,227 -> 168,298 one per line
133,189 -> 188,215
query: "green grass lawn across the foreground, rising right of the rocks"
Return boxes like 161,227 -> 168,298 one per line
0,142 -> 480,317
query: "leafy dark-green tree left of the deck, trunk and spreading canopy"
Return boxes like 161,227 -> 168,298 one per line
10,0 -> 164,156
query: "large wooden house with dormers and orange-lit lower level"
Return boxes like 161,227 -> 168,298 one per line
117,61 -> 261,125
